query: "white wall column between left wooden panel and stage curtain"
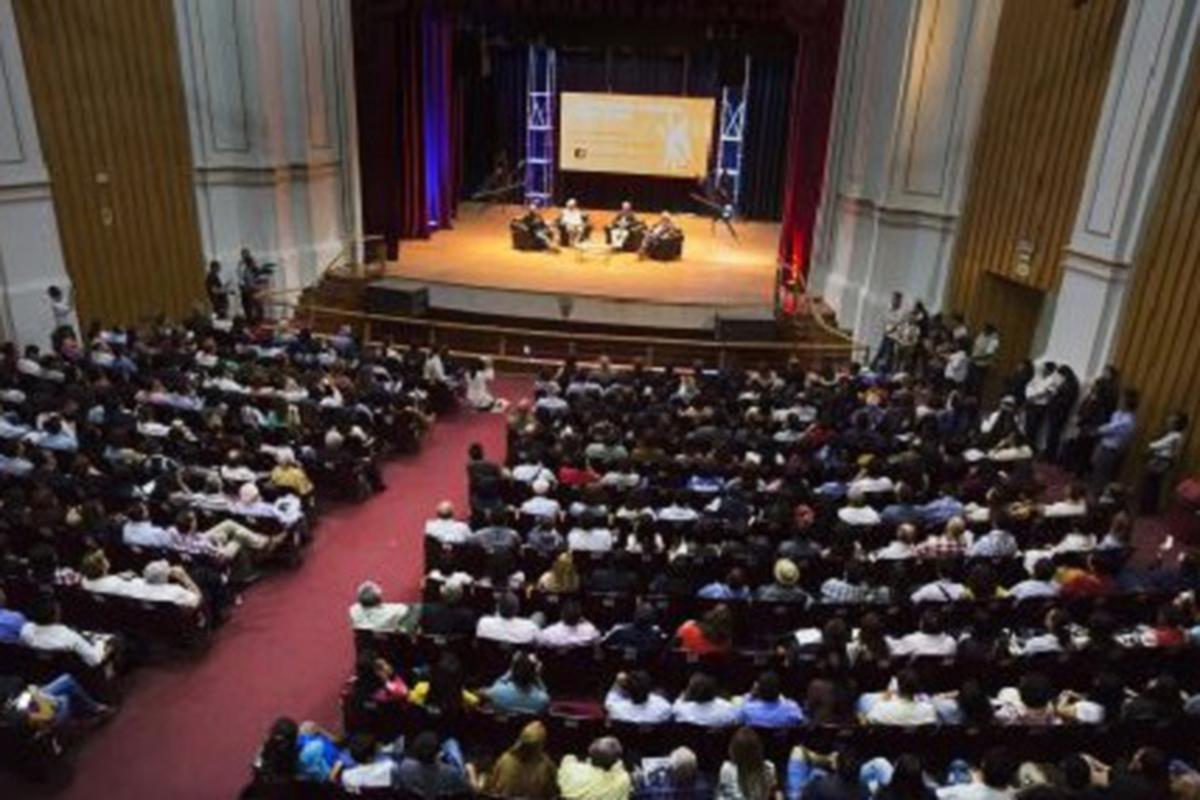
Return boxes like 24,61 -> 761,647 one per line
175,0 -> 358,297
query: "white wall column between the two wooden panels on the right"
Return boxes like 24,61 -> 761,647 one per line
1042,0 -> 1200,378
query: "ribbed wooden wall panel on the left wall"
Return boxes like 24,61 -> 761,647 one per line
14,0 -> 203,325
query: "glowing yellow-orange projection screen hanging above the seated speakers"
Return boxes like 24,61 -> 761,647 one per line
558,91 -> 716,178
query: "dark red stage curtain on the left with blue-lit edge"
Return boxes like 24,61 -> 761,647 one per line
352,0 -> 462,258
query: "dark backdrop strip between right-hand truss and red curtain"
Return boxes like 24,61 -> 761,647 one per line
740,55 -> 794,219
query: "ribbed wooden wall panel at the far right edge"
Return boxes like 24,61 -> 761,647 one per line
1115,48 -> 1200,469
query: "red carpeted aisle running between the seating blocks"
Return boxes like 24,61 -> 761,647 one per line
0,380 -> 529,800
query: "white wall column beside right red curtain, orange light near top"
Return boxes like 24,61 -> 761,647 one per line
810,0 -> 1002,344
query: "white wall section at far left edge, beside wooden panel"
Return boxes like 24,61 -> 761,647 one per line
0,0 -> 70,347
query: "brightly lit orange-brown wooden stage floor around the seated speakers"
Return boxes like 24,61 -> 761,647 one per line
386,203 -> 779,307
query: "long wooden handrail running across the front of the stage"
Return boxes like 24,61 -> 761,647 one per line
270,301 -> 865,353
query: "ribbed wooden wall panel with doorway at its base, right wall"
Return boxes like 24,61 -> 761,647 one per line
947,0 -> 1126,388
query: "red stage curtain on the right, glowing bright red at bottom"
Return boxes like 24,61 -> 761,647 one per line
779,0 -> 842,287
